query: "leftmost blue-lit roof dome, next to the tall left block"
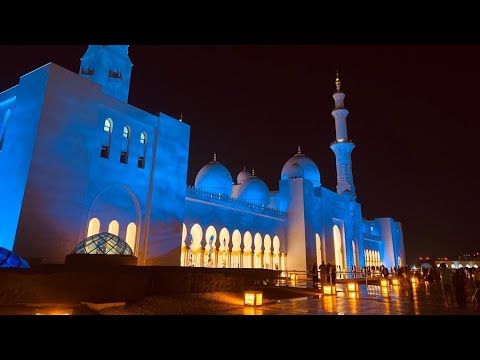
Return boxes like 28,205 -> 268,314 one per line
195,160 -> 233,195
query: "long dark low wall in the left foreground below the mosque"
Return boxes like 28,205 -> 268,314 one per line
0,265 -> 280,304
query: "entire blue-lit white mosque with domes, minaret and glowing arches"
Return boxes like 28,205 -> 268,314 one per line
0,45 -> 405,271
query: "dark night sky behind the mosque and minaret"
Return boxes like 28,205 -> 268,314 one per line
0,45 -> 480,262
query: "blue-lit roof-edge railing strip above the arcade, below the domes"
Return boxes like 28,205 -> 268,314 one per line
187,186 -> 286,217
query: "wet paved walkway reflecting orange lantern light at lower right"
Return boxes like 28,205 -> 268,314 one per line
217,284 -> 480,315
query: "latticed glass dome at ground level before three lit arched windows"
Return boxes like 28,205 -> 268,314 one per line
72,233 -> 133,255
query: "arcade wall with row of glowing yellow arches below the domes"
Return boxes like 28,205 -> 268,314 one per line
183,196 -> 286,269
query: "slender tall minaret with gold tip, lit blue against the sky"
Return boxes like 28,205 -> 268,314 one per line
330,71 -> 355,195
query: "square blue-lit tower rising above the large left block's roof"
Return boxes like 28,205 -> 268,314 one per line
80,45 -> 133,102
